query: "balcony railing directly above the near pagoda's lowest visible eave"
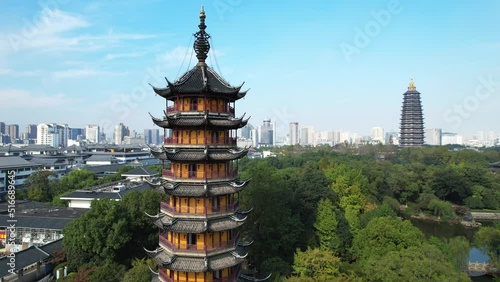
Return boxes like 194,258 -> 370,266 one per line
160,232 -> 240,253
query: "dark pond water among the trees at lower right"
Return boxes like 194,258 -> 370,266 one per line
411,218 -> 494,282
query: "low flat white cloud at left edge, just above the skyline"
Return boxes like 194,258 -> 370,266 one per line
0,89 -> 78,110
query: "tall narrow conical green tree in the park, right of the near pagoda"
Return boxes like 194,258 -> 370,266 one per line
314,199 -> 340,251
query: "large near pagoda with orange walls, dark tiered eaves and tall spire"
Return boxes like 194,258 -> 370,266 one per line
146,7 -> 264,282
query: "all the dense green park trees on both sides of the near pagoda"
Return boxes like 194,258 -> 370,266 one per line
16,146 -> 500,282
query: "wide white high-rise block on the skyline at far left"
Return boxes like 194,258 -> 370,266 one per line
36,123 -> 71,147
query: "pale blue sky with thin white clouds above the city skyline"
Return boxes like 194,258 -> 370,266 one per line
0,0 -> 500,139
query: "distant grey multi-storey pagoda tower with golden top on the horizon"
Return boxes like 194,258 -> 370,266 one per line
399,79 -> 424,147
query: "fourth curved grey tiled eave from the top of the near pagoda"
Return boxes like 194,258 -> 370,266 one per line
148,179 -> 251,197
